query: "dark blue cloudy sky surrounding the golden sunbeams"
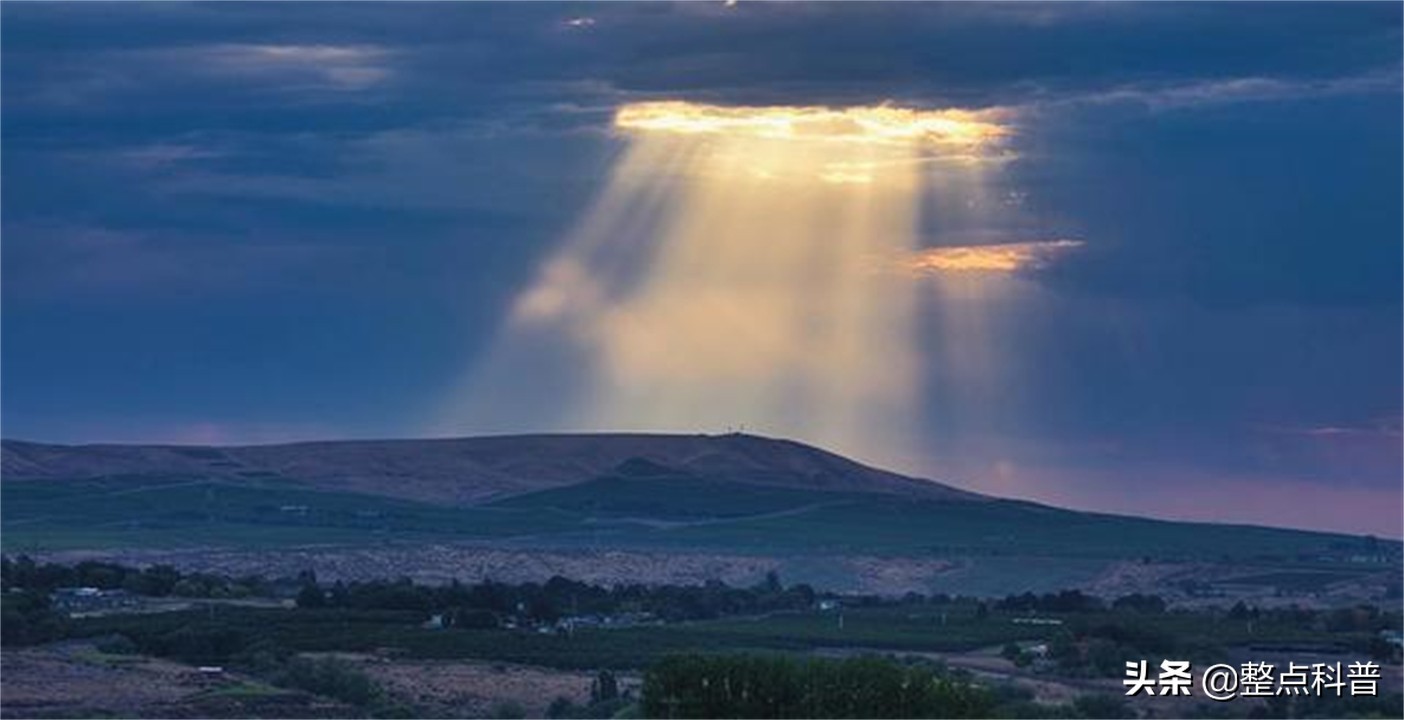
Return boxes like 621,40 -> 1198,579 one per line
0,1 -> 1404,538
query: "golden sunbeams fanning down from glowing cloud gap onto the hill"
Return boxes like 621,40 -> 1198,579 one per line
448,102 -> 1038,468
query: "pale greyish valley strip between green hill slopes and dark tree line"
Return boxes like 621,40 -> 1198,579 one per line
28,543 -> 1400,608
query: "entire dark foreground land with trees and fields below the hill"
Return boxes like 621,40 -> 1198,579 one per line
0,557 -> 1404,717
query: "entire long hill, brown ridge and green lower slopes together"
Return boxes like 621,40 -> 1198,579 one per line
0,434 -> 1398,589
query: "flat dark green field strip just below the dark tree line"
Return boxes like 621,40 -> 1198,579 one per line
63,602 -> 1370,669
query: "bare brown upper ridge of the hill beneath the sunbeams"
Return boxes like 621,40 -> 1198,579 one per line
0,434 -> 984,505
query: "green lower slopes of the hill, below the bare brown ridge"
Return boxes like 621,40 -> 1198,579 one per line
0,463 -> 1398,572
